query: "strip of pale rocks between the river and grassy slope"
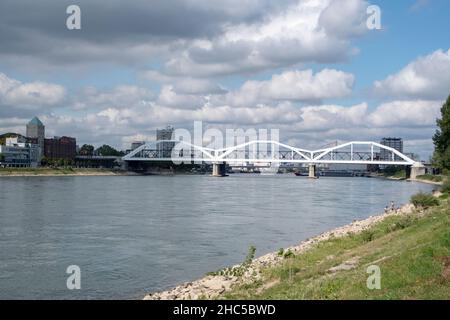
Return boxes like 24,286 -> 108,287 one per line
144,204 -> 414,300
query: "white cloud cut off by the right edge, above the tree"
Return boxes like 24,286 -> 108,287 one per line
374,50 -> 450,100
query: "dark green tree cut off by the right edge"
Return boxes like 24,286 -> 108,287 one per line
433,96 -> 450,170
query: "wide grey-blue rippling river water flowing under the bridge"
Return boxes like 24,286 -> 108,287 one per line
0,175 -> 433,299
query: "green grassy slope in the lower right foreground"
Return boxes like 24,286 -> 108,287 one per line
223,200 -> 450,299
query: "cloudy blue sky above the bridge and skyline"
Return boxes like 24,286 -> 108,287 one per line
0,0 -> 450,160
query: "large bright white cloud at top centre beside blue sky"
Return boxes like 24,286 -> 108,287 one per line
165,0 -> 367,76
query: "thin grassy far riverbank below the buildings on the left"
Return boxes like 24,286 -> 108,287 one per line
0,168 -> 124,177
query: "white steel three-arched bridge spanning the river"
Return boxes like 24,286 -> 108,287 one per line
122,140 -> 421,177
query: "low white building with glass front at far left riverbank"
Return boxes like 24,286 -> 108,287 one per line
0,136 -> 40,168
